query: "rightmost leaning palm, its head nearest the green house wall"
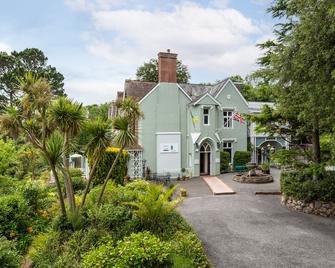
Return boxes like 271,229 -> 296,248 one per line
98,116 -> 135,205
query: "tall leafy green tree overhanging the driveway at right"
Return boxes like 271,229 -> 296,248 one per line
254,0 -> 335,163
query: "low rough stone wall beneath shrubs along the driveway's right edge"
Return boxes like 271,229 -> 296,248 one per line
282,196 -> 335,217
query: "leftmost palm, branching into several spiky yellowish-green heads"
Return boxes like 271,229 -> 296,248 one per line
0,73 -> 66,216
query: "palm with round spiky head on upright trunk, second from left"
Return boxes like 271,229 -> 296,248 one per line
49,97 -> 85,211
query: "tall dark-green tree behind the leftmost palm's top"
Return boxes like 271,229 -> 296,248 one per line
0,48 -> 64,111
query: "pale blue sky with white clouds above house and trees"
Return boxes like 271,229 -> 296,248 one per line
0,0 -> 274,104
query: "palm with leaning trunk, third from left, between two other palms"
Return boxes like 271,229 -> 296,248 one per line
80,119 -> 111,208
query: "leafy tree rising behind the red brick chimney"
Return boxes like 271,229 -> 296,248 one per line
136,59 -> 191,83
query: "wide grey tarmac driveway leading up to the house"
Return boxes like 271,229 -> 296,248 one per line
180,171 -> 335,268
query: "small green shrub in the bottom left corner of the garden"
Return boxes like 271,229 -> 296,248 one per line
0,236 -> 22,268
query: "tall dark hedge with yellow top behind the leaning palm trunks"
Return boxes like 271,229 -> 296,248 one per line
89,147 -> 129,185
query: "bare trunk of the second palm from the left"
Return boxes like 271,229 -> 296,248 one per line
63,134 -> 76,212
